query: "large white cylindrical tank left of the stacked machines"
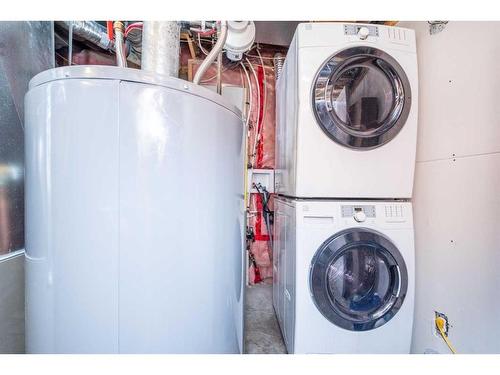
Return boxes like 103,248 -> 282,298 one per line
25,66 -> 244,353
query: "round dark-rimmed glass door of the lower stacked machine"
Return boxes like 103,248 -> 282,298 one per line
310,228 -> 408,331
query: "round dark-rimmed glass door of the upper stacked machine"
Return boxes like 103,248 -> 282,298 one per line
312,47 -> 411,150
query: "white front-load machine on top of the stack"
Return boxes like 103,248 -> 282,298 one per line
275,23 -> 418,198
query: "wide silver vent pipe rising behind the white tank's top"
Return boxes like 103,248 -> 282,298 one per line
141,21 -> 181,77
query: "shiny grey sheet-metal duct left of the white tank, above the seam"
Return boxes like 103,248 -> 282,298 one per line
0,21 -> 55,256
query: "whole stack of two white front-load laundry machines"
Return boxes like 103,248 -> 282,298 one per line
273,23 -> 418,353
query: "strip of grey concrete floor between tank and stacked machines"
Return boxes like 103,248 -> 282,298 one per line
245,284 -> 286,354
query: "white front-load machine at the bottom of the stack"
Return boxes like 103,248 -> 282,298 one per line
273,197 -> 415,353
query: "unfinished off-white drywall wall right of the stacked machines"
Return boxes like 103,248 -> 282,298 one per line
399,22 -> 500,353
